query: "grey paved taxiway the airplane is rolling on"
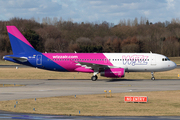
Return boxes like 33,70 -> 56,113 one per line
0,79 -> 180,101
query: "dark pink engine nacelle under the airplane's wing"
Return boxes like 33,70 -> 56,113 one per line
101,68 -> 125,78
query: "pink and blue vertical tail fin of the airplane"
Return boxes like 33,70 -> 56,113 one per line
6,26 -> 37,55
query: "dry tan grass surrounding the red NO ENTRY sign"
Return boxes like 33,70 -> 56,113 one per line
0,91 -> 180,116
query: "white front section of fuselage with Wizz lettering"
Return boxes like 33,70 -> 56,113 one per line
104,53 -> 176,72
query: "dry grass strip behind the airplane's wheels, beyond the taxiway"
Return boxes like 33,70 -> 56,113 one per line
0,68 -> 180,79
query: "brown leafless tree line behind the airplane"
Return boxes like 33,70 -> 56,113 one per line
0,17 -> 180,57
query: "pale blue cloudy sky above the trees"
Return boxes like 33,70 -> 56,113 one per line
0,0 -> 180,24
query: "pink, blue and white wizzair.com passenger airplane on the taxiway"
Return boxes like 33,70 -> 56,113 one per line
3,26 -> 176,81
